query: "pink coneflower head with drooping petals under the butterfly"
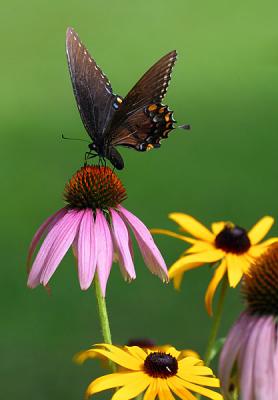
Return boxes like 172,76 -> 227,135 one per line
28,166 -> 168,296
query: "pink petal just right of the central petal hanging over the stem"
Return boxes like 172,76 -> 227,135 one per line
110,209 -> 136,279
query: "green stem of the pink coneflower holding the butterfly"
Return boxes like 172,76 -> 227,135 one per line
94,274 -> 116,372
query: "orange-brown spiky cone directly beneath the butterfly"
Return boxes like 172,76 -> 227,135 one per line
64,165 -> 127,210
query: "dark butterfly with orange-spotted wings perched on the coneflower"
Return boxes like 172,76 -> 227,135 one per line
66,28 -> 189,169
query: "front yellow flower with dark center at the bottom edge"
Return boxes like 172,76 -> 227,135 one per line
77,344 -> 223,400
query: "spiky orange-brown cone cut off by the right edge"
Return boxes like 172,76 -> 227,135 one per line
242,243 -> 278,316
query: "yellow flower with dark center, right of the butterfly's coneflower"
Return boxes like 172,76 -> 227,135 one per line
152,213 -> 278,315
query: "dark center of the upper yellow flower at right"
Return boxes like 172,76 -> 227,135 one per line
215,224 -> 251,254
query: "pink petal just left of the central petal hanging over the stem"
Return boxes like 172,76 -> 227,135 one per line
75,209 -> 97,290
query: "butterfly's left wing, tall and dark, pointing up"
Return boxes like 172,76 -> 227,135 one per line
66,28 -> 121,142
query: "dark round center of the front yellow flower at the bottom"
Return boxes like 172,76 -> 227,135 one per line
144,352 -> 178,378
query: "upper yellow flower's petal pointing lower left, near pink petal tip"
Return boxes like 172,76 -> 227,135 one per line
169,249 -> 225,279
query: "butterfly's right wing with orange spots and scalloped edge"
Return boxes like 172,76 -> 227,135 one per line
105,50 -> 177,151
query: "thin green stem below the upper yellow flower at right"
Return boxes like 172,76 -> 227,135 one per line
204,275 -> 228,367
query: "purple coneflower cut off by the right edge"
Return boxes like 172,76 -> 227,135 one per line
219,244 -> 278,400
